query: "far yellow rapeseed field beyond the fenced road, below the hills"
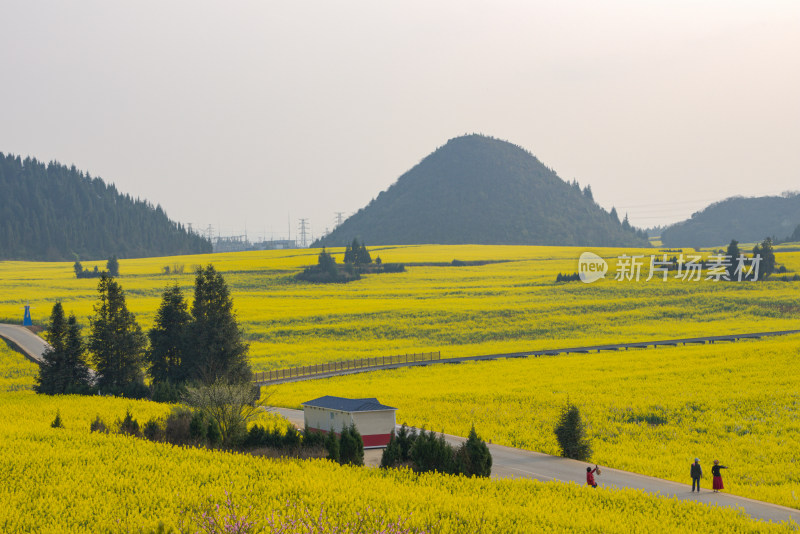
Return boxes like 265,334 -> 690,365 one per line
0,245 -> 800,370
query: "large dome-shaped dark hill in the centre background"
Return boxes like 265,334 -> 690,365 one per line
314,135 -> 649,246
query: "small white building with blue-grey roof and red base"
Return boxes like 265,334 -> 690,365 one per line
303,395 -> 397,449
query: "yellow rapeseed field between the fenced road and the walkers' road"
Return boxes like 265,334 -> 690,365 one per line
270,335 -> 800,508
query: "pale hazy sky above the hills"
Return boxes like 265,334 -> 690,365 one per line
0,0 -> 800,238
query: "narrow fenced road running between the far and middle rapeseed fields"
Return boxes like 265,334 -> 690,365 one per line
255,330 -> 800,385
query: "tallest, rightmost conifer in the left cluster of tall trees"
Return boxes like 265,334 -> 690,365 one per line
188,264 -> 252,384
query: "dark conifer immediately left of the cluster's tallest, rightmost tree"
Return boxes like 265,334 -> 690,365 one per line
145,282 -> 192,384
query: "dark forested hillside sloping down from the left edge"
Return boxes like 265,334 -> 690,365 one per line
0,152 -> 211,261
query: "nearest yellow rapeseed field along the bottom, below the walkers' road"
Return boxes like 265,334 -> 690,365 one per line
0,392 -> 793,534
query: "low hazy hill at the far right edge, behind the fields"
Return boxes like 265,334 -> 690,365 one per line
661,194 -> 800,247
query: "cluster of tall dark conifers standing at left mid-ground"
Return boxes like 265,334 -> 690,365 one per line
36,264 -> 251,400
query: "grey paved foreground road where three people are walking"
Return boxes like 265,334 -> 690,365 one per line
271,408 -> 800,522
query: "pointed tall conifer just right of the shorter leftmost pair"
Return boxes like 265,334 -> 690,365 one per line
89,275 -> 146,393
